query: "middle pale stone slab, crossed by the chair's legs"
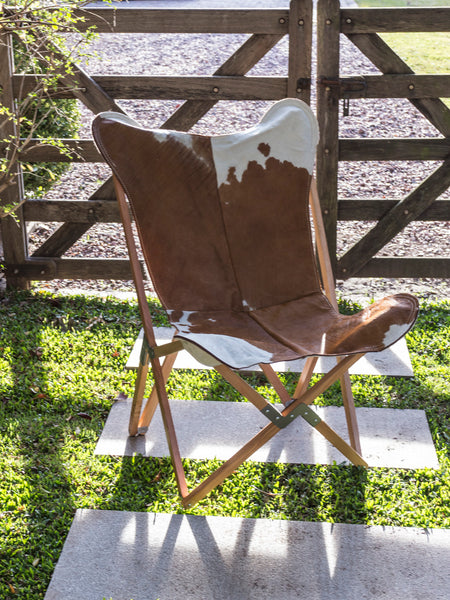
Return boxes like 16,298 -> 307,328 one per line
95,399 -> 439,469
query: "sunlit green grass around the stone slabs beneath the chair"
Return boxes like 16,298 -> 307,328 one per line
0,292 -> 450,600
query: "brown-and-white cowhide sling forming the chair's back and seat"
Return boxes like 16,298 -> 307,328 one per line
93,106 -> 418,368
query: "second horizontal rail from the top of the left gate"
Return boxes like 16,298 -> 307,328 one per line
13,75 -> 287,100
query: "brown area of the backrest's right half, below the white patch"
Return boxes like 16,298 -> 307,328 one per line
219,158 -> 320,310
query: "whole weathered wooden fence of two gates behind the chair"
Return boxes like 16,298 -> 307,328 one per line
0,0 -> 450,287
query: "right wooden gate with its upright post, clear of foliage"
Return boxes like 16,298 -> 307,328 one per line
317,0 -> 450,279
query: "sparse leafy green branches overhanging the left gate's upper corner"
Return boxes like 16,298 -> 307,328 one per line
0,0 -> 93,217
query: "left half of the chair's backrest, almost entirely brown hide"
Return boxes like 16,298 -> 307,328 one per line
94,118 -> 241,310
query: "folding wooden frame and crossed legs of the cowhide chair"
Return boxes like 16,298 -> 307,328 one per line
114,177 -> 368,508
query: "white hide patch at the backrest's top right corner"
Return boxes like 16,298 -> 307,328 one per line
211,98 -> 319,186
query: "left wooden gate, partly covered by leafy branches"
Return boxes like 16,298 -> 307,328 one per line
0,0 -> 312,287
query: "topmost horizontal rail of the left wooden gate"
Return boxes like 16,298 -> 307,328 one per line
74,6 -> 289,34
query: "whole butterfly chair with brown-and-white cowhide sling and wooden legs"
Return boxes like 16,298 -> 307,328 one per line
93,99 -> 418,506
